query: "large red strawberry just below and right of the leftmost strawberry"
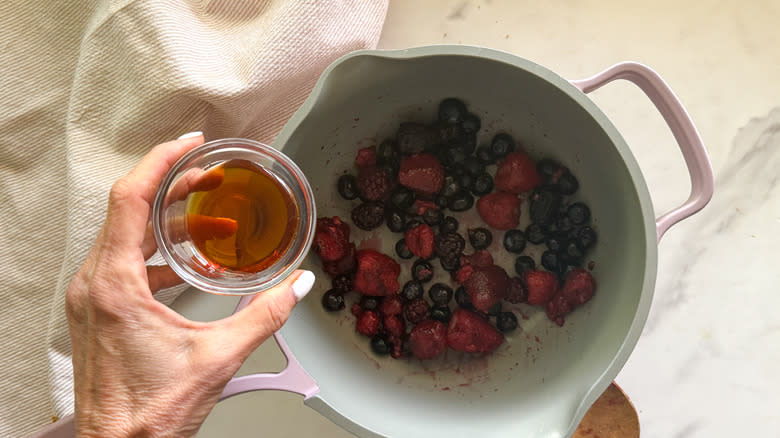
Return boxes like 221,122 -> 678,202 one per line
353,249 -> 401,296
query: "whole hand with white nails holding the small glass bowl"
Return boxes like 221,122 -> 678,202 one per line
66,135 -> 314,437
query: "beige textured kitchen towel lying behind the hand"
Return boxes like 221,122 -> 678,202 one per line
0,0 -> 387,437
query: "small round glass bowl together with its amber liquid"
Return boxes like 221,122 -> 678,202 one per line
152,138 -> 317,295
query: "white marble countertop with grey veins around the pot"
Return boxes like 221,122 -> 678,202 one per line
189,0 -> 780,437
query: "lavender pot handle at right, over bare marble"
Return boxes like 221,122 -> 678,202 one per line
571,62 -> 715,240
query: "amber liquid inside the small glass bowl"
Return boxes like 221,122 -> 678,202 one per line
186,160 -> 300,272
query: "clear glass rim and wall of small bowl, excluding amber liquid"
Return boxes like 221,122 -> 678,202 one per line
152,138 -> 317,295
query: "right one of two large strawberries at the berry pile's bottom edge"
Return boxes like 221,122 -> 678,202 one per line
447,309 -> 504,353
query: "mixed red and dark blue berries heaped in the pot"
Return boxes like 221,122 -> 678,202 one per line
312,98 -> 597,360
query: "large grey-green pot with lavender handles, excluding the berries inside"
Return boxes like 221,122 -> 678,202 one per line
33,46 -> 713,438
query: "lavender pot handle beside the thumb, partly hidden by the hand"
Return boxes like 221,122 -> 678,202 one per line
219,295 -> 319,401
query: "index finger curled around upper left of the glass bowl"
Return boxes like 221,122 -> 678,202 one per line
106,134 -> 203,249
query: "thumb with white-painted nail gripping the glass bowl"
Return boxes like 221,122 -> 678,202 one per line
222,270 -> 314,360
